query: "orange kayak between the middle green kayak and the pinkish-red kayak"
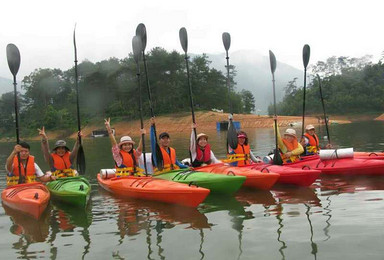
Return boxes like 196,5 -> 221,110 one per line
195,163 -> 280,190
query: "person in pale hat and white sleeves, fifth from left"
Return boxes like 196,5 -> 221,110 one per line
189,124 -> 221,167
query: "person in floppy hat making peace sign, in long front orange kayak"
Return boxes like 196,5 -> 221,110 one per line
104,118 -> 145,177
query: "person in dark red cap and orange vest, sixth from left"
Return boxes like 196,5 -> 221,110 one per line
227,131 -> 261,166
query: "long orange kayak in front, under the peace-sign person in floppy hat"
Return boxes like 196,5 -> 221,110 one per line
97,174 -> 209,207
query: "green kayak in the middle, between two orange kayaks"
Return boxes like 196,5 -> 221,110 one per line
154,170 -> 246,193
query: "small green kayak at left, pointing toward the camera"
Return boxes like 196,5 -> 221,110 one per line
47,176 -> 91,207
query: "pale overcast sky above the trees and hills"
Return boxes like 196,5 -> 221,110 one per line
0,0 -> 384,80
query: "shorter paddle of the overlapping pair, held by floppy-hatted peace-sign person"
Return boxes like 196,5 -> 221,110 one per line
132,36 -> 148,176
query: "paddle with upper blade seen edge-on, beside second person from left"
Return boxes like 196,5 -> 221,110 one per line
73,25 -> 86,175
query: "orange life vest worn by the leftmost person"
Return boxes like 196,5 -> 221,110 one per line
7,155 -> 36,186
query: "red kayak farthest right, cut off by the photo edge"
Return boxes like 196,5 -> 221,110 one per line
285,155 -> 384,175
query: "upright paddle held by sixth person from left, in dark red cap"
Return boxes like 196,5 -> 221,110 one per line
222,32 -> 238,153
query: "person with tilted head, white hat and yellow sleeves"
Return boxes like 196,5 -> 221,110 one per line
277,128 -> 304,163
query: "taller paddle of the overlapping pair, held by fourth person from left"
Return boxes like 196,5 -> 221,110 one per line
136,23 -> 163,168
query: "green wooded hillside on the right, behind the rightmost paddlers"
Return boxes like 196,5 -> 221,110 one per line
268,55 -> 384,115
